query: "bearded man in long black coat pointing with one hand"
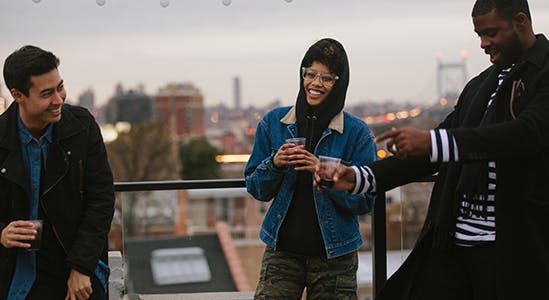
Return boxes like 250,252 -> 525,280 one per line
317,0 -> 549,300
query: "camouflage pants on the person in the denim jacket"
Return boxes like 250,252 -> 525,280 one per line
254,247 -> 358,300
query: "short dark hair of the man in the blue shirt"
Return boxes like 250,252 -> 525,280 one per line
4,45 -> 59,97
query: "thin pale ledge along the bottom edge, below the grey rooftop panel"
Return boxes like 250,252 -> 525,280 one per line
122,292 -> 254,300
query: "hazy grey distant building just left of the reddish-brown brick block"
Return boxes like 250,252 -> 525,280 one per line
104,90 -> 153,124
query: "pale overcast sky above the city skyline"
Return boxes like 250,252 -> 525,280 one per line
0,0 -> 549,106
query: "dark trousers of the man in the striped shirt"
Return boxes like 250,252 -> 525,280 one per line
410,244 -> 497,300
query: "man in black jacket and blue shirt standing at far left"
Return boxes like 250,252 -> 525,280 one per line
0,46 -> 114,300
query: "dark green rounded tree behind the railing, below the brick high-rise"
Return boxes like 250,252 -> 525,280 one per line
179,137 -> 221,179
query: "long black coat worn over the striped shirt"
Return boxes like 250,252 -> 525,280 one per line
371,35 -> 549,300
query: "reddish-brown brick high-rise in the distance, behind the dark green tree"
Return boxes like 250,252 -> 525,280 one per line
154,83 -> 205,140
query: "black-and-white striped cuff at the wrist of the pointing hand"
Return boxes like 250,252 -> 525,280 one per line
430,129 -> 459,162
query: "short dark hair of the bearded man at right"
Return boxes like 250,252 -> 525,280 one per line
472,0 -> 532,22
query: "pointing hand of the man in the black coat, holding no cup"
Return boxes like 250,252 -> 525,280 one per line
376,127 -> 431,159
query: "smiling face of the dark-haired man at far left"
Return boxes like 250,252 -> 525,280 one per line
11,69 -> 67,138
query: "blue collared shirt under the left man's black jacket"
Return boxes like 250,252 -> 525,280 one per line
8,115 -> 53,300
